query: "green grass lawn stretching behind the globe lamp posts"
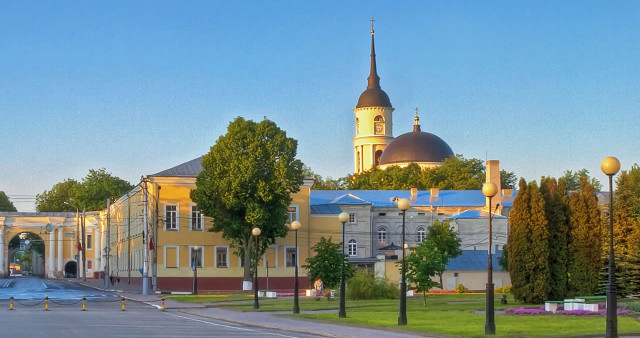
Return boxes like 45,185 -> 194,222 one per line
172,294 -> 640,337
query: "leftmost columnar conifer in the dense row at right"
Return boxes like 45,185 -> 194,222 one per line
507,179 -> 551,303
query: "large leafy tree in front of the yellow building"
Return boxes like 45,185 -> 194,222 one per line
191,117 -> 304,281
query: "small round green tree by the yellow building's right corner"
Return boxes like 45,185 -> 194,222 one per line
303,237 -> 353,288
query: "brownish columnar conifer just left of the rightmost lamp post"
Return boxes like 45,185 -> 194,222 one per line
561,177 -> 604,297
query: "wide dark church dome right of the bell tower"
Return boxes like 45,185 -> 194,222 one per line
380,117 -> 454,165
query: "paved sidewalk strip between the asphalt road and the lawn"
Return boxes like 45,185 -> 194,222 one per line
68,278 -> 427,338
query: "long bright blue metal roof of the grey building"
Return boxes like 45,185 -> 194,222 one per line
310,190 -> 515,207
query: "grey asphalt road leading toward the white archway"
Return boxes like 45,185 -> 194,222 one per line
0,277 -> 317,338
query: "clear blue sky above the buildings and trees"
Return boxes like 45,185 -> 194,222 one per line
0,1 -> 640,211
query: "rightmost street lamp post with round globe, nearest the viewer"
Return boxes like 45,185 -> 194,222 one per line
600,156 -> 620,338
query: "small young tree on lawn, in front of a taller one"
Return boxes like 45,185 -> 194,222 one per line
398,240 -> 446,306
